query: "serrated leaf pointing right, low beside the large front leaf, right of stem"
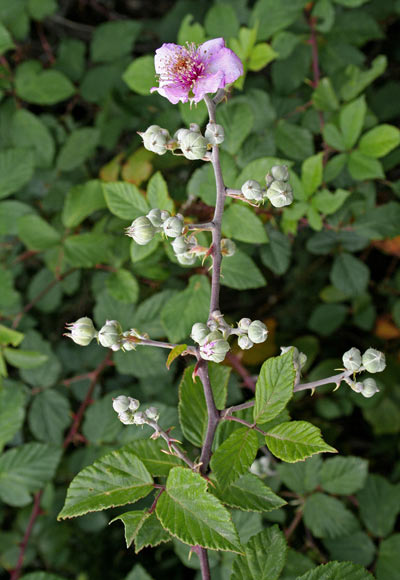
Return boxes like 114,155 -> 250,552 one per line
210,473 -> 286,512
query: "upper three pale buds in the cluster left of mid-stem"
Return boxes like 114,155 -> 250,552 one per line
125,208 -> 185,246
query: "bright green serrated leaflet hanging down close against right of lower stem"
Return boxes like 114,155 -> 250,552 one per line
210,427 -> 258,488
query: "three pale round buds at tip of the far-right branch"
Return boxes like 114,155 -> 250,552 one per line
342,347 -> 386,399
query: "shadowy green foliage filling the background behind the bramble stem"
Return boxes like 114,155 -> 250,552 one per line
0,0 -> 400,580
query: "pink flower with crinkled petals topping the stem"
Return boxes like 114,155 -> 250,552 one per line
151,38 -> 243,104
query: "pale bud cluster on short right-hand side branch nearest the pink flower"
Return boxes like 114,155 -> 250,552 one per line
241,165 -> 293,207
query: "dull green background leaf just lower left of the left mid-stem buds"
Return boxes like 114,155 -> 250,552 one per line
64,232 -> 112,268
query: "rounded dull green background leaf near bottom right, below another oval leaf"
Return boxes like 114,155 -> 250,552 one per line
304,492 -> 359,538
